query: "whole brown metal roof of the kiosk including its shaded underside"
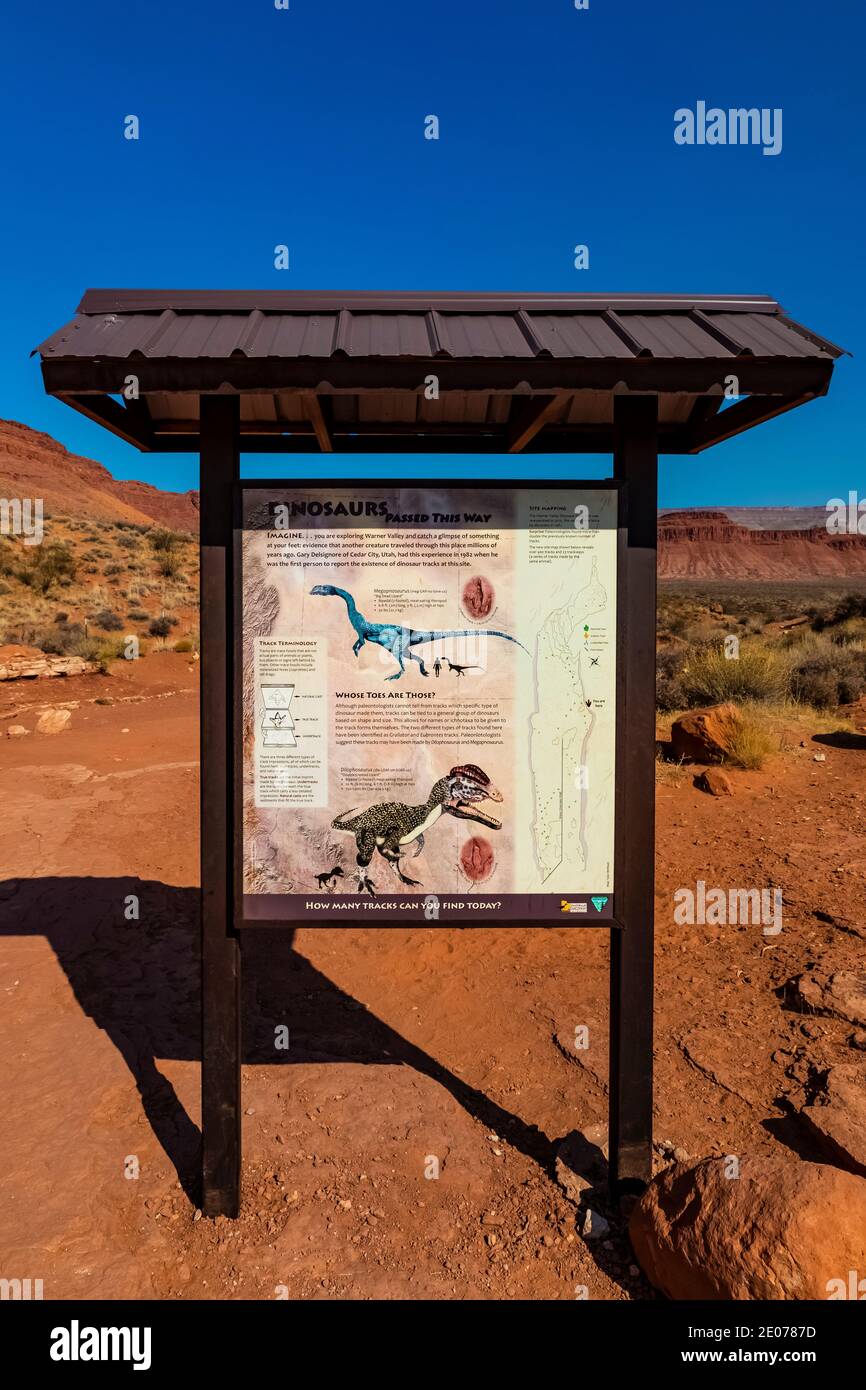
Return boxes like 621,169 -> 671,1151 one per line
38,289 -> 842,452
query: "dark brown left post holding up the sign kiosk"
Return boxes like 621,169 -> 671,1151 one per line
199,396 -> 240,1216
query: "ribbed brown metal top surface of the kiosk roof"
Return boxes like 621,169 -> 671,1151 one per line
38,291 -> 842,360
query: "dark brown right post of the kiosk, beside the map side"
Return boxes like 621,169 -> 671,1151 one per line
609,396 -> 659,1195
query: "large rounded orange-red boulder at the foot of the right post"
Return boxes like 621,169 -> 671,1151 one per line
628,1155 -> 866,1300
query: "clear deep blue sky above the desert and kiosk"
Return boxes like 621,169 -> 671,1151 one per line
0,0 -> 866,506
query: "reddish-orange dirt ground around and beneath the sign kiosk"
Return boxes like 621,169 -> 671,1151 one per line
0,653 -> 866,1298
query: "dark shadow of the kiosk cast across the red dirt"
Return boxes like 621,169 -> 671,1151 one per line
0,878 -> 555,1205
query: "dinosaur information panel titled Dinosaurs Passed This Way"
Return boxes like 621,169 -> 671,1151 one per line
239,481 -> 619,926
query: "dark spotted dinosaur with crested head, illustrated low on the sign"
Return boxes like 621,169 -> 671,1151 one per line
331,763 -> 502,898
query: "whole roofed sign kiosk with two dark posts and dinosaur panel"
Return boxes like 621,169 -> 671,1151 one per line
39,291 -> 841,1216
